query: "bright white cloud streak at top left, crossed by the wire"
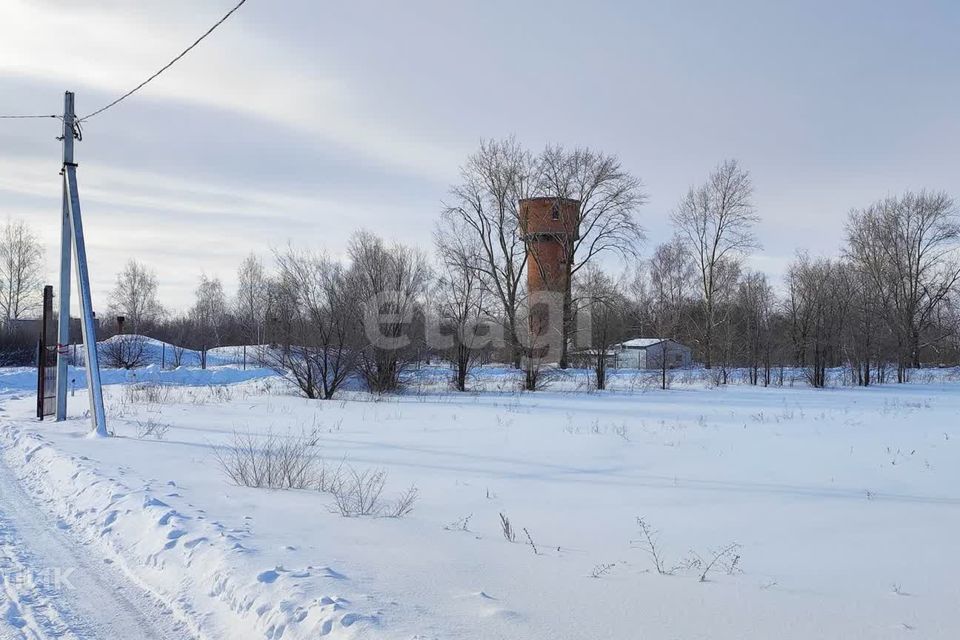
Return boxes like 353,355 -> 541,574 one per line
0,0 -> 459,178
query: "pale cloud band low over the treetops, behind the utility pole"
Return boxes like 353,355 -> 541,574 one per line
0,157 -> 433,309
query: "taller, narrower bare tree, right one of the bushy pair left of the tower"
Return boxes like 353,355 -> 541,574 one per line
349,231 -> 430,393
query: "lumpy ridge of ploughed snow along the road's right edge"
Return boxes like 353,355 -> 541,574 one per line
0,425 -> 379,639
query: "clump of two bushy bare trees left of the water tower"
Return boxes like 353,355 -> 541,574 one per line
267,231 -> 430,399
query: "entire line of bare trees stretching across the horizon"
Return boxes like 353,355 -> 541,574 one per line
0,138 -> 960,398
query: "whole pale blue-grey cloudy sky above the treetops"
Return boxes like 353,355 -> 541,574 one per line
0,0 -> 960,311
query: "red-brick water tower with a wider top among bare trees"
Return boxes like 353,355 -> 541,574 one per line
520,198 -> 580,336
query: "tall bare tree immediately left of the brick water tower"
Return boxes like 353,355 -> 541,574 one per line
435,138 -> 537,367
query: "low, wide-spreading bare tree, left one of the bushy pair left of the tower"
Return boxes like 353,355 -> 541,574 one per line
268,248 -> 362,400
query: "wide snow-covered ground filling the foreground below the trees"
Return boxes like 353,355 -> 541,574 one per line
0,368 -> 960,640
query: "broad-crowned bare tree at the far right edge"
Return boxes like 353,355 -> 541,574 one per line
847,191 -> 960,382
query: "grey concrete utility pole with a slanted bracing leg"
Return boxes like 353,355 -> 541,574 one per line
57,91 -> 109,436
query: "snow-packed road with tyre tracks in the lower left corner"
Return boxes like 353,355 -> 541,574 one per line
0,452 -> 192,640
